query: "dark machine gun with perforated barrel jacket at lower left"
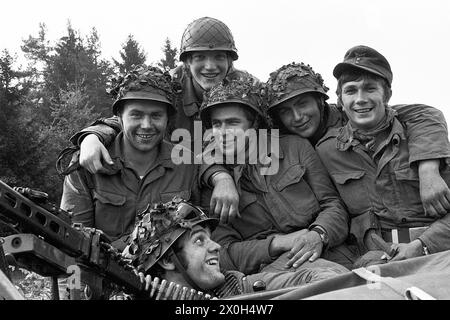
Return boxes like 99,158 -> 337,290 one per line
0,180 -> 144,299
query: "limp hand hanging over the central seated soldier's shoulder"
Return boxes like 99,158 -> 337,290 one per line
210,172 -> 241,223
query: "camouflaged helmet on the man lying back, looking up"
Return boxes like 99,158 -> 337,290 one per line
123,197 -> 219,273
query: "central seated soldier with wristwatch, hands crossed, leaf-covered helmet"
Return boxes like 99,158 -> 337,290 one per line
200,79 -> 348,280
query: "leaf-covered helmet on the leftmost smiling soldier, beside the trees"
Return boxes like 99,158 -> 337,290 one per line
108,65 -> 181,115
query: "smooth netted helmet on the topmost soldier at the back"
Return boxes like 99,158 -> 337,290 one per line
180,17 -> 238,61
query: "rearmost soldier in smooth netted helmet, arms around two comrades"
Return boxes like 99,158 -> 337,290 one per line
63,17 -> 253,221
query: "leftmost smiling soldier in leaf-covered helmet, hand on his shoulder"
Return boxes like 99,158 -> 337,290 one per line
61,66 -> 200,249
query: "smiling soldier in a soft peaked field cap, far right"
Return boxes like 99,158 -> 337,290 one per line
317,46 -> 450,264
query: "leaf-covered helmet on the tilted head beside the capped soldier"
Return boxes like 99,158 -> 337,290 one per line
266,62 -> 329,114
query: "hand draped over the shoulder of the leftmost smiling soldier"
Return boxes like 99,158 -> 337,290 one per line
80,134 -> 113,174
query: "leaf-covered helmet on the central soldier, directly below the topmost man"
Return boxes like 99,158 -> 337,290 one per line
200,76 -> 266,128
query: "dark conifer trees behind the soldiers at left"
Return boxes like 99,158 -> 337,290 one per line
0,22 -> 176,203
